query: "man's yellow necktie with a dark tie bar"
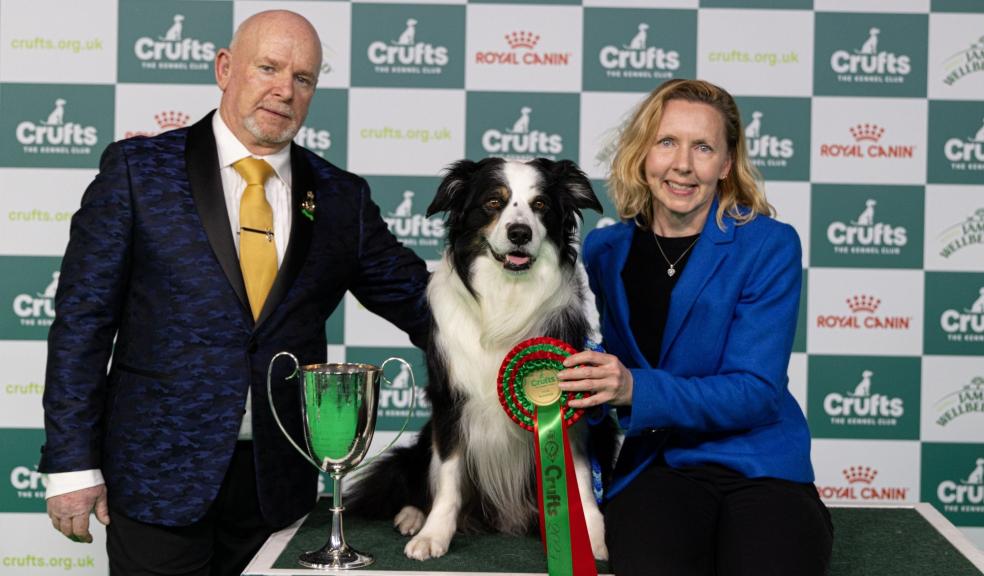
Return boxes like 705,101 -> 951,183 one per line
232,157 -> 277,321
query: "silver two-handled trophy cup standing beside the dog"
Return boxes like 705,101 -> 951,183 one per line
267,352 -> 416,570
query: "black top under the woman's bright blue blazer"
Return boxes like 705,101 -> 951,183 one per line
622,226 -> 700,368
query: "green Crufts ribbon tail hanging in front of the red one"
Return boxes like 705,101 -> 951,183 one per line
536,402 -> 574,576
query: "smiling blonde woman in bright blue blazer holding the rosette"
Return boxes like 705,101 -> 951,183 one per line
560,80 -> 832,576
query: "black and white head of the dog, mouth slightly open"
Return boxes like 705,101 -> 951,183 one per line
427,158 -> 601,289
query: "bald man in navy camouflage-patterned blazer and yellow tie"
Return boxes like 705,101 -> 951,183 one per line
41,10 -> 429,575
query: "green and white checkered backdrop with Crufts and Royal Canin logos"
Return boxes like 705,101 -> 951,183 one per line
0,0 -> 984,574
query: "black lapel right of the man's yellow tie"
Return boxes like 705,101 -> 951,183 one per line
256,142 -> 317,327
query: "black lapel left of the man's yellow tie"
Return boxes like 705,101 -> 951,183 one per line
185,111 -> 249,310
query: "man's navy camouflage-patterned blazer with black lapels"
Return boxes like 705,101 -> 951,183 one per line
41,114 -> 430,526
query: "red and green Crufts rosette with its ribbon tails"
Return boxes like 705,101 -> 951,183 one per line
498,338 -> 598,576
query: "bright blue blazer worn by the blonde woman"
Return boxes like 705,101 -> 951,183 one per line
584,202 -> 813,497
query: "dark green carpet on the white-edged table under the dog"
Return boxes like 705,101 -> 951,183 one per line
273,499 -> 981,576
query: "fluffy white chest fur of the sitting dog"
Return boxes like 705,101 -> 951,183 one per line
428,246 -> 574,532
